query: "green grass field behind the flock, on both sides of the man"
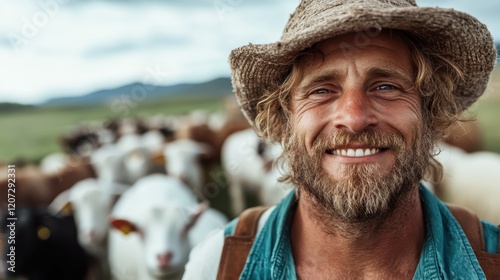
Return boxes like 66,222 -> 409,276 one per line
0,68 -> 500,162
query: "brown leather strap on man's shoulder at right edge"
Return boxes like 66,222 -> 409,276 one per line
448,204 -> 500,279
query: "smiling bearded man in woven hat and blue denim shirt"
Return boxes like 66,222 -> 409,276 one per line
184,0 -> 500,279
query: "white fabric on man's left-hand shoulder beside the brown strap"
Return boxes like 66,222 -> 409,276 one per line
182,206 -> 275,280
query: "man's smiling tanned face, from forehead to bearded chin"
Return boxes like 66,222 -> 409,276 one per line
285,32 -> 431,221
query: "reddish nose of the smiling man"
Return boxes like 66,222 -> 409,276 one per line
333,87 -> 378,133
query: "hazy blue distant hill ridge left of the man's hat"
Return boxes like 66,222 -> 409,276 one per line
40,78 -> 232,106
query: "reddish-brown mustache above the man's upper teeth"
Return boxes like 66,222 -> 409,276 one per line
312,129 -> 405,154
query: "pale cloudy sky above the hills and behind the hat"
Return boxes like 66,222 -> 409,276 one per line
0,0 -> 500,104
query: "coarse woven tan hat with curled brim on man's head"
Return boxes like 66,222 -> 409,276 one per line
229,0 -> 496,124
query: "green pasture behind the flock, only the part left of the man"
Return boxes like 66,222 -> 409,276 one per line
0,97 -> 223,163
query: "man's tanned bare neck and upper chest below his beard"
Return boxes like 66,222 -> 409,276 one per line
291,187 -> 425,279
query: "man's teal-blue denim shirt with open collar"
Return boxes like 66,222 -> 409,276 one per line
225,186 -> 499,280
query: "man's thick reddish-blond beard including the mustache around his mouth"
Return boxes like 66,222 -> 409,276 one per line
284,125 -> 432,228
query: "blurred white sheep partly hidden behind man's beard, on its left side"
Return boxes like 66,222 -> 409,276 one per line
221,129 -> 293,215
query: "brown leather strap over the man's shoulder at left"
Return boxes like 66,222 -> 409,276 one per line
217,206 -> 269,280
